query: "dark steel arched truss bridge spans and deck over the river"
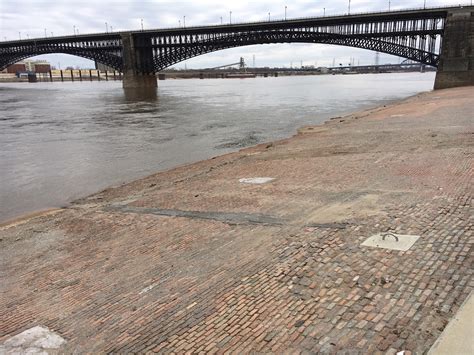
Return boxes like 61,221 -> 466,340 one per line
0,7 -> 470,75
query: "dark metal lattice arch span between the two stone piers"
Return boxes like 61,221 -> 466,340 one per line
148,8 -> 446,71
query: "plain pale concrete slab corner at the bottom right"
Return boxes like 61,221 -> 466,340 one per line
428,292 -> 474,355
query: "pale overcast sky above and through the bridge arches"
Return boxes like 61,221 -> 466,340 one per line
0,0 -> 470,68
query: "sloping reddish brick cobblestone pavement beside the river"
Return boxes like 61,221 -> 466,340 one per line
0,87 -> 474,354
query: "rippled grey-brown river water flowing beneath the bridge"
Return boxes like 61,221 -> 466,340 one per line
0,73 -> 434,221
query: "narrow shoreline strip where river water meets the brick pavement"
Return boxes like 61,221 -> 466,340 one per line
0,90 -> 433,231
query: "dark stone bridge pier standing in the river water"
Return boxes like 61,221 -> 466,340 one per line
121,33 -> 158,97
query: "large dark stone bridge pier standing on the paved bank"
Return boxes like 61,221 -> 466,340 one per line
434,7 -> 474,90
